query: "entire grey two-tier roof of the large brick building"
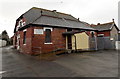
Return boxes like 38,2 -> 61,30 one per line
17,7 -> 94,30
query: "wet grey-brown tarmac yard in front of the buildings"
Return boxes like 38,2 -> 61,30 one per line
0,46 -> 118,77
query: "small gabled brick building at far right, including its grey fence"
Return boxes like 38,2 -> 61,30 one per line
91,19 -> 119,49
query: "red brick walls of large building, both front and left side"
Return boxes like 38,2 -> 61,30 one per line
13,26 -> 66,54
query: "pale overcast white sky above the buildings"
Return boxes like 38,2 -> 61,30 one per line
0,0 -> 120,37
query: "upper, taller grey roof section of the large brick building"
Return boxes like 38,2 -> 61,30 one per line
23,7 -> 77,24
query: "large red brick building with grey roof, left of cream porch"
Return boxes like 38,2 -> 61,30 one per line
13,7 -> 94,54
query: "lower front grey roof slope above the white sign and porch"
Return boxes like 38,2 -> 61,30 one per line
33,16 -> 92,29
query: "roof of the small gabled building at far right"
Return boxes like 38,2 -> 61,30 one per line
91,22 -> 119,31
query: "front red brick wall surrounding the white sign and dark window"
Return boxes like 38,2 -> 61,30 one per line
32,27 -> 66,53
